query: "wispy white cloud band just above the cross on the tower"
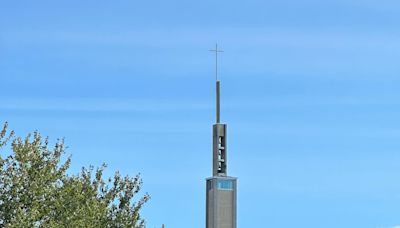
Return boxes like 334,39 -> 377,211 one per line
2,27 -> 400,49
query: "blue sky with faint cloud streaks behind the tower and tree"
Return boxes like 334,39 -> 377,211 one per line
0,0 -> 400,228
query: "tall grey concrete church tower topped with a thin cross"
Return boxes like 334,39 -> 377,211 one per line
206,44 -> 237,228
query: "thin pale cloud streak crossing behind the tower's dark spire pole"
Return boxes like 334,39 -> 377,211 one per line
0,93 -> 400,113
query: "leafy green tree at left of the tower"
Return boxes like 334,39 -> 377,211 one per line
0,123 -> 150,228
